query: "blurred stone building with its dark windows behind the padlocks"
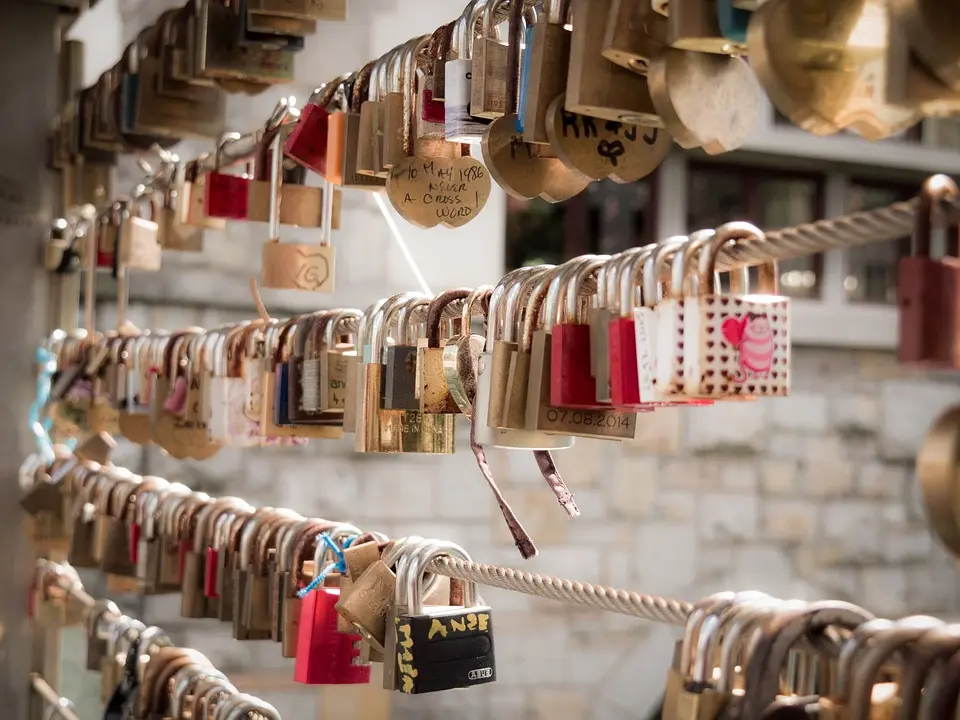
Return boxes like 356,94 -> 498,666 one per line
54,0 -> 960,720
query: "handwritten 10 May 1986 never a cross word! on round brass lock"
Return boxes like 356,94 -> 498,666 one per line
390,160 -> 487,222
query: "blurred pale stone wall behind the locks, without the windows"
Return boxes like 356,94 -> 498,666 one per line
60,0 -> 960,720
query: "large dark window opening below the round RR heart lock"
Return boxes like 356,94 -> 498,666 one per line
506,175 -> 656,270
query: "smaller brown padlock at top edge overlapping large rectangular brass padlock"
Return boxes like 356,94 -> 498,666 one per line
600,0 -> 668,74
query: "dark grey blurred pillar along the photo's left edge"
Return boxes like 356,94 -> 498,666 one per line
0,0 -> 58,718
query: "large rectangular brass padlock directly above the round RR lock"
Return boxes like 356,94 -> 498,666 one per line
568,0 -> 659,127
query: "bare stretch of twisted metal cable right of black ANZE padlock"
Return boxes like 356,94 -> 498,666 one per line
429,557 -> 693,626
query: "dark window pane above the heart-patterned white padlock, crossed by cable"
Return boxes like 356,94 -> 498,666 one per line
687,163 -> 824,298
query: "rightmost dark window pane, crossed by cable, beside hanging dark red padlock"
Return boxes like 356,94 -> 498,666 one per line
843,180 -> 917,304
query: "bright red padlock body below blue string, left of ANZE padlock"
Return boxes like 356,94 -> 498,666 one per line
293,587 -> 370,685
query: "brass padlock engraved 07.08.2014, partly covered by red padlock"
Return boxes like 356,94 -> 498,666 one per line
509,256 -> 636,440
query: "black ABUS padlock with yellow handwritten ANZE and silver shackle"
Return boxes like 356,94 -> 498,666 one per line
389,540 -> 497,694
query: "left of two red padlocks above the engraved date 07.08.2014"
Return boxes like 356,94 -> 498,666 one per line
544,256 -> 611,409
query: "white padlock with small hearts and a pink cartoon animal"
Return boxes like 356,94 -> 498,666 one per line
683,222 -> 790,398
